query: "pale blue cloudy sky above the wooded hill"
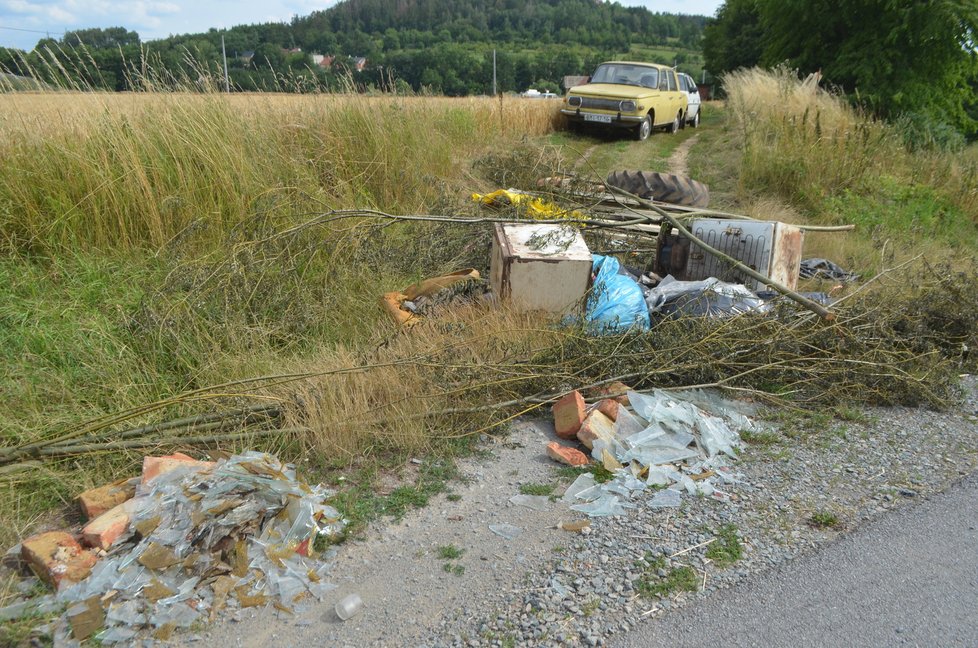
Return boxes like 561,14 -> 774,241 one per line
0,0 -> 722,50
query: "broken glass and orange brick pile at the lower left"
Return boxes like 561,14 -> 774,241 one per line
13,452 -> 346,645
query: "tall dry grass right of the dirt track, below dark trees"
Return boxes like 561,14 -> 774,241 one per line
724,67 -> 978,222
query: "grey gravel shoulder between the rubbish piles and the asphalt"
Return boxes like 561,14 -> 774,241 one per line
189,377 -> 978,646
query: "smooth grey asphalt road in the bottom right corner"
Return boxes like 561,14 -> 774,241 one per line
612,474 -> 978,648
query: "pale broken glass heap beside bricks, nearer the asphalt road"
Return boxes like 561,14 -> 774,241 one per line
563,390 -> 755,517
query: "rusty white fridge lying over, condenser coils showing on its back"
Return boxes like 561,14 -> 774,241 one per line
655,218 -> 804,290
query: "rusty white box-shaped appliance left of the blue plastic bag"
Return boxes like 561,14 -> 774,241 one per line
489,223 -> 591,313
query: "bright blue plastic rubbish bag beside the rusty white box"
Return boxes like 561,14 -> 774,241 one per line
584,254 -> 650,334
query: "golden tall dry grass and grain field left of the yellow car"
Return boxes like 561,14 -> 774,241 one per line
0,92 -> 555,252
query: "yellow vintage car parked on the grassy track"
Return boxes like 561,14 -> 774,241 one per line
560,61 -> 688,140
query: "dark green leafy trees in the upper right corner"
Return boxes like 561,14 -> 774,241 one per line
703,0 -> 978,136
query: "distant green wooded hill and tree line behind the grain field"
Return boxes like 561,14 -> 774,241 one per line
0,0 -> 707,95
